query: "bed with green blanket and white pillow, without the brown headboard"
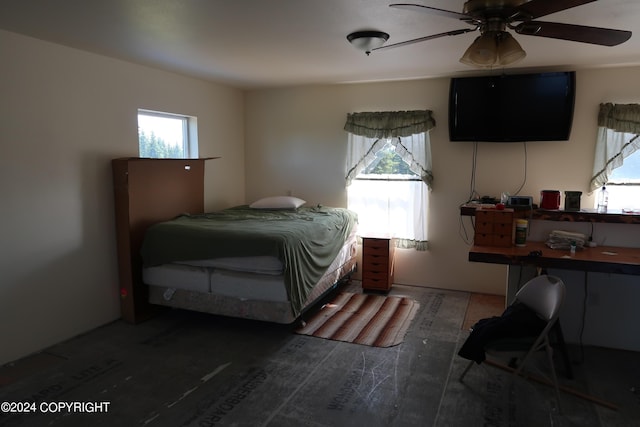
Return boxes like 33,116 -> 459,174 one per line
141,204 -> 357,324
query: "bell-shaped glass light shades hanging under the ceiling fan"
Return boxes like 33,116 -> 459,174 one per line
460,31 -> 527,67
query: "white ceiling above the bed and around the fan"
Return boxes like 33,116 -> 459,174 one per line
0,0 -> 640,88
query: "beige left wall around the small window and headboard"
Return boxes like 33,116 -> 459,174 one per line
0,31 -> 244,364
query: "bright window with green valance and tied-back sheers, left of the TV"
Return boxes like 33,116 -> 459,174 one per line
344,110 -> 435,250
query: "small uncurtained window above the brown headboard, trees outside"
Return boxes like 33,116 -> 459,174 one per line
138,110 -> 198,159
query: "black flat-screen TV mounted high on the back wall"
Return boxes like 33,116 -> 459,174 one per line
449,71 -> 575,142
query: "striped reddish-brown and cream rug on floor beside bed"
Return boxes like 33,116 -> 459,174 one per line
295,292 -> 420,347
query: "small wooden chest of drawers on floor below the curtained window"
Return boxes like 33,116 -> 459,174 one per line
362,236 -> 395,292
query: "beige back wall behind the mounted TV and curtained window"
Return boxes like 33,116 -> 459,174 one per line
246,68 -> 640,294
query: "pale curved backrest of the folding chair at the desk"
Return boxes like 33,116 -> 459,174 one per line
516,274 -> 565,321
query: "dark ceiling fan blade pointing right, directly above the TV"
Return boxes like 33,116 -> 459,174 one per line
514,21 -> 631,46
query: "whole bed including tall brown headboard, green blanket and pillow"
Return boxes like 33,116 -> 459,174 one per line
112,157 -> 356,323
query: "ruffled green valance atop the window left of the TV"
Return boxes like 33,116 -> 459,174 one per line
344,110 -> 436,139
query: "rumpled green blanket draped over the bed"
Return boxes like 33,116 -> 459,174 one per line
141,206 -> 357,317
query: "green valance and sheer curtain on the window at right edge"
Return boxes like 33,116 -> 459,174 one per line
590,103 -> 640,191
